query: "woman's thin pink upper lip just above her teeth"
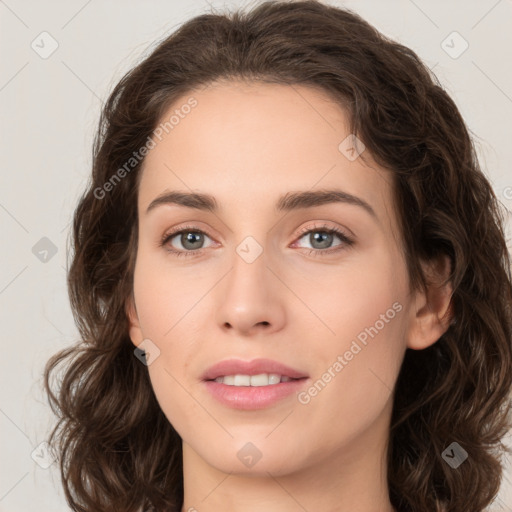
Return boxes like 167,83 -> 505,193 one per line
202,359 -> 308,380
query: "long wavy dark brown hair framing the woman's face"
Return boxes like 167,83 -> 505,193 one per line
44,0 -> 512,512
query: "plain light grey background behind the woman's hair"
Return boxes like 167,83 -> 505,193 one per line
0,0 -> 512,512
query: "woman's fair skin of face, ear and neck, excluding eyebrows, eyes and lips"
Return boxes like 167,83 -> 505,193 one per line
127,82 -> 452,512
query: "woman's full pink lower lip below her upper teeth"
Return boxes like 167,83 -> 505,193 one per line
204,378 -> 308,410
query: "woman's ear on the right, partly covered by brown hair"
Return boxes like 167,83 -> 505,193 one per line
407,255 -> 453,350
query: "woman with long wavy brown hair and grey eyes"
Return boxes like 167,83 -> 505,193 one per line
45,1 -> 512,512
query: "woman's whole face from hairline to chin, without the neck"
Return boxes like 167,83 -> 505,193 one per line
129,82 -> 439,475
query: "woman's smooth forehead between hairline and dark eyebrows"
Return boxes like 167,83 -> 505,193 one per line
139,81 -> 391,228
